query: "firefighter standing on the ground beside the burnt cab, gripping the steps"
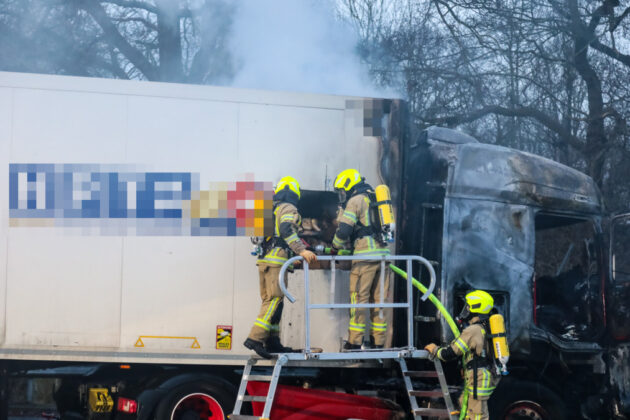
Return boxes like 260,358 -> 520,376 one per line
424,290 -> 500,420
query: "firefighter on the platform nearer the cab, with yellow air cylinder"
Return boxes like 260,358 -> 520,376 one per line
332,169 -> 389,350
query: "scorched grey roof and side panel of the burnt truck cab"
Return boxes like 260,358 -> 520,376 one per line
420,127 -> 603,354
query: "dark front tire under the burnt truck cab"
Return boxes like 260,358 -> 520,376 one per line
488,380 -> 567,420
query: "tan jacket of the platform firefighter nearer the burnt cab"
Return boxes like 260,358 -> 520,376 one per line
333,193 -> 389,255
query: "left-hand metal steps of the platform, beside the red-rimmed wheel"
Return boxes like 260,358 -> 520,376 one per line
228,354 -> 289,420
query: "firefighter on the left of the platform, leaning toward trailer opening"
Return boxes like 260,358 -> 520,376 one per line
243,176 -> 317,358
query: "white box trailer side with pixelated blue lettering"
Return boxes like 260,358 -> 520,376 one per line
0,73 -> 410,420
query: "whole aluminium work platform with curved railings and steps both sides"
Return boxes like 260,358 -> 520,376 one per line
229,256 -> 459,420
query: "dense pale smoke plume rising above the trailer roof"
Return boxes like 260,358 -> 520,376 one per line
229,0 -> 395,97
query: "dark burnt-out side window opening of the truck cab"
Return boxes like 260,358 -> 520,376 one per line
534,214 -> 603,340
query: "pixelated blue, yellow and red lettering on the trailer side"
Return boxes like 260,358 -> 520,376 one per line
9,163 -> 273,236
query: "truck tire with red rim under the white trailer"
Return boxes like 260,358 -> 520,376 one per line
155,378 -> 236,420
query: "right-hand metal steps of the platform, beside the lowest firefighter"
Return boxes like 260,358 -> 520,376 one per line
396,358 -> 459,420
